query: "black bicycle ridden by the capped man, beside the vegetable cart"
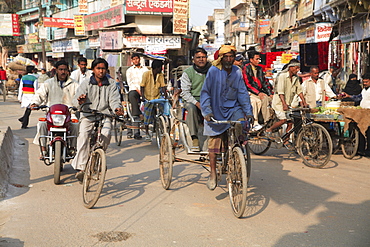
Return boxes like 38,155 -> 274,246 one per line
248,108 -> 333,168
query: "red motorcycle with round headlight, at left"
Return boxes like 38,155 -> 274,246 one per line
39,104 -> 78,184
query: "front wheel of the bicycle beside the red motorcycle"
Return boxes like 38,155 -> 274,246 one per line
82,148 -> 107,208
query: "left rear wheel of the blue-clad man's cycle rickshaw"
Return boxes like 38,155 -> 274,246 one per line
159,133 -> 174,190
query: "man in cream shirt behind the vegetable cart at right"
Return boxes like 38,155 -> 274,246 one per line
302,66 -> 337,108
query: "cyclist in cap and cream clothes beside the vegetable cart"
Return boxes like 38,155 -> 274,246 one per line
266,59 -> 307,145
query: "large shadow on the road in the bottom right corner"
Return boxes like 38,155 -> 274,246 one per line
273,201 -> 370,247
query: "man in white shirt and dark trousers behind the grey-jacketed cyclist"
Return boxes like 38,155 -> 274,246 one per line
126,53 -> 148,140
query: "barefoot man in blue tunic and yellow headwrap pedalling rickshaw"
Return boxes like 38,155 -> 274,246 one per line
200,45 -> 253,190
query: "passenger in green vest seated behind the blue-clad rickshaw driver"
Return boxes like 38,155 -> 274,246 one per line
181,47 -> 211,152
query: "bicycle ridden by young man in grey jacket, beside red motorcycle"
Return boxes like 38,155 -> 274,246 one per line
82,110 -> 115,208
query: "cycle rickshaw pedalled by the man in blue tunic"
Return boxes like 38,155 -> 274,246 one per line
159,116 -> 251,218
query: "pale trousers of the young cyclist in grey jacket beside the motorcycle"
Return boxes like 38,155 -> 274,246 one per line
71,117 -> 112,170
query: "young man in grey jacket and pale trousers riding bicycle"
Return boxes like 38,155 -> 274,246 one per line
72,58 -> 123,182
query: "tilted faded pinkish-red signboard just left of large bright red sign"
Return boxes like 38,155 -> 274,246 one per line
84,5 -> 125,31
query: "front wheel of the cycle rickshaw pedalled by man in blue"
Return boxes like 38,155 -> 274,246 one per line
227,147 -> 248,218
